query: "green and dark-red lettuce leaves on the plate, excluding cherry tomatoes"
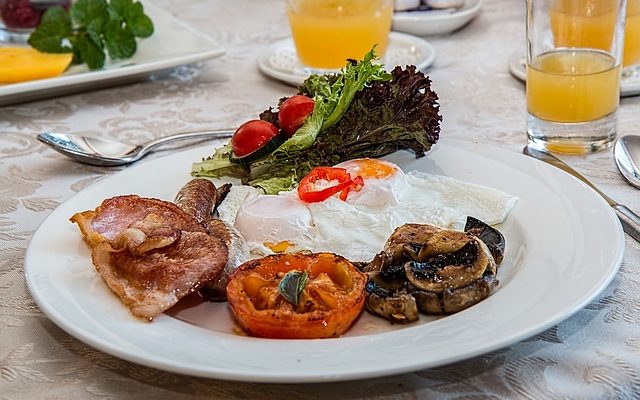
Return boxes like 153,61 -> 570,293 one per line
193,58 -> 442,194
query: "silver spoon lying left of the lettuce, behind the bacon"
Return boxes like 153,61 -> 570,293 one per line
37,129 -> 235,167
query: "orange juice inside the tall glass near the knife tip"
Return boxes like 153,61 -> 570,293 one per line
527,49 -> 620,122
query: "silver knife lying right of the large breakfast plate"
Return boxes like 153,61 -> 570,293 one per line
522,146 -> 640,242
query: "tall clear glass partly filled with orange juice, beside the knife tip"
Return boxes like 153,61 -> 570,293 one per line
527,0 -> 626,153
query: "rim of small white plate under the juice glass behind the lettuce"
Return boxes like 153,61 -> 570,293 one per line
257,31 -> 436,86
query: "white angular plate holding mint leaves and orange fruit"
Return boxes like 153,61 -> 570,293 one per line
0,1 -> 225,106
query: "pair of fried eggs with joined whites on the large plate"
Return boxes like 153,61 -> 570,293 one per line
221,159 -> 517,261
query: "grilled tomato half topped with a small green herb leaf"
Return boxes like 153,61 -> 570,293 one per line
227,253 -> 367,339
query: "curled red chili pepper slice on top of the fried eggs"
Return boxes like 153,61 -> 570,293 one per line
298,167 -> 364,203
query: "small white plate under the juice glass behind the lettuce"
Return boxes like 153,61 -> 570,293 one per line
258,32 -> 436,86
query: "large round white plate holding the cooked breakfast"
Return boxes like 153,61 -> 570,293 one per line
24,140 -> 624,383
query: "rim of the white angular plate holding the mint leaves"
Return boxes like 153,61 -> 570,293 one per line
0,0 -> 226,105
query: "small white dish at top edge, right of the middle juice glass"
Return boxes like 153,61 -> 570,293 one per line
391,0 -> 482,36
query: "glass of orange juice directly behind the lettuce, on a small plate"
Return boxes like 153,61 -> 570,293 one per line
287,0 -> 393,69
